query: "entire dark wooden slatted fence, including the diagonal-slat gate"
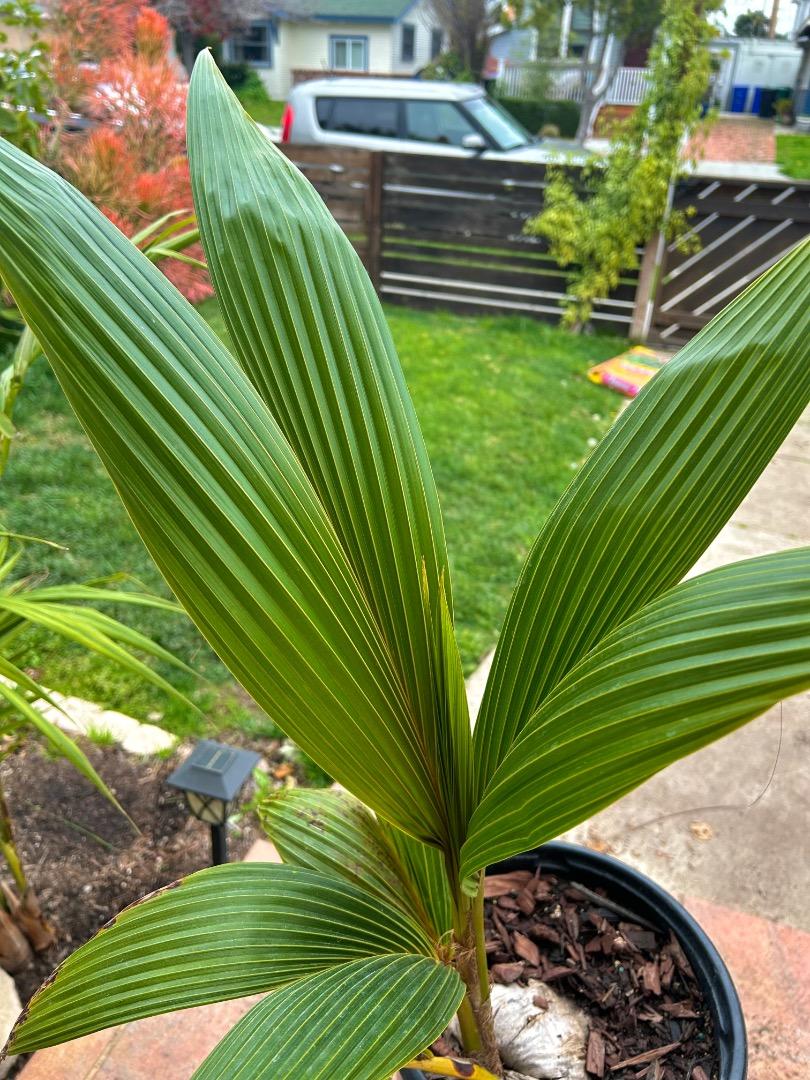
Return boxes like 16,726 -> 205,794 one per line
284,146 -> 810,345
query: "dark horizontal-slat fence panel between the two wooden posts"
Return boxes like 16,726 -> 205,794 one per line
380,154 -> 637,333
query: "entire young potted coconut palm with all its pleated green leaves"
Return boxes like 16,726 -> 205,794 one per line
0,55 -> 810,1080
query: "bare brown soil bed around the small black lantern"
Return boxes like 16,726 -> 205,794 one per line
0,738 -> 292,1003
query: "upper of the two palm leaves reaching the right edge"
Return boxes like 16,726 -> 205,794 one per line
475,241 -> 810,791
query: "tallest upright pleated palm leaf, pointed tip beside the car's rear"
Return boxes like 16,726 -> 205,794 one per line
188,53 -> 470,839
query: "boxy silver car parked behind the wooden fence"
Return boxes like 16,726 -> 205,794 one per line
281,78 -> 583,163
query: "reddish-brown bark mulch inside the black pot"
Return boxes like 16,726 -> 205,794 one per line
486,870 -> 717,1080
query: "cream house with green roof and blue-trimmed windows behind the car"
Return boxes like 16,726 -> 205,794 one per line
222,0 -> 445,98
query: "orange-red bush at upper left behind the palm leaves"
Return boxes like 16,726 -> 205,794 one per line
49,0 -> 212,302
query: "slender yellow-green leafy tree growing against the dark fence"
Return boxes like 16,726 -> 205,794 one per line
527,0 -> 721,328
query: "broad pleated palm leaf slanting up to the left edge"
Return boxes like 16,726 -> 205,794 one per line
0,132 -> 448,840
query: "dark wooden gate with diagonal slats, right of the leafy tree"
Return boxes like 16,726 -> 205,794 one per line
651,177 -> 810,345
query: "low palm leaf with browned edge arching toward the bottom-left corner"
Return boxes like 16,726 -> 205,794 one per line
9,863 -> 435,1053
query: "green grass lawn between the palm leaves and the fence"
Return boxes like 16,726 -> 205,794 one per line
3,300 -> 623,734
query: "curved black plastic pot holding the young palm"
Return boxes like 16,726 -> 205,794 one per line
402,840 -> 748,1080
